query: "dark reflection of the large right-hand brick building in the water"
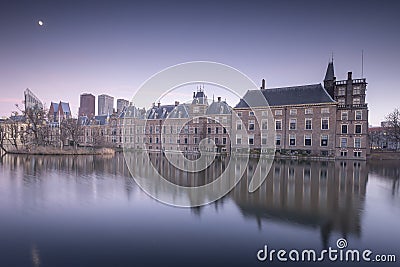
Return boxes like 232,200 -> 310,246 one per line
231,161 -> 368,249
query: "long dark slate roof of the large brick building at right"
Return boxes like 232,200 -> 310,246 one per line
235,84 -> 335,108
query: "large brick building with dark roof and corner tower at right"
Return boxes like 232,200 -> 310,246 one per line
232,62 -> 369,159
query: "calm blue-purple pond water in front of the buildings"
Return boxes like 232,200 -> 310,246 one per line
0,154 -> 400,267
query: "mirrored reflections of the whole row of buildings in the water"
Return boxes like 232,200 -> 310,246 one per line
2,153 -> 368,246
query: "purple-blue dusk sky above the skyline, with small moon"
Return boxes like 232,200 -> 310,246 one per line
0,0 -> 400,125
